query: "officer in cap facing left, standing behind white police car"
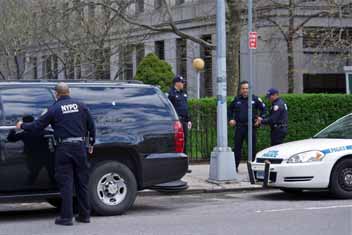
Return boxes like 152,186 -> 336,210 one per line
258,88 -> 288,146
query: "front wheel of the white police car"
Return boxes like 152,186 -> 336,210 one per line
330,159 -> 352,198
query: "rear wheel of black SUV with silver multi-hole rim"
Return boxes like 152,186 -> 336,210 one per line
89,161 -> 137,215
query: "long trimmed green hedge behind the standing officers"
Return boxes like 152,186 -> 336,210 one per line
187,94 -> 352,160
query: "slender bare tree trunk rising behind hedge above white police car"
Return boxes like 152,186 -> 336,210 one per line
287,0 -> 295,93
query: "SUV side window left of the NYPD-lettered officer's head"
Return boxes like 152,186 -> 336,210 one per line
0,88 -> 54,126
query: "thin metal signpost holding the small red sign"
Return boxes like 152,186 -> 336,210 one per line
248,0 -> 254,161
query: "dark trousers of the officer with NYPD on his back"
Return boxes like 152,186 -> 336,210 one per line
55,143 -> 90,219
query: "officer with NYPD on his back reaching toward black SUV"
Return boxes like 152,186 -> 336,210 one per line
16,83 -> 95,225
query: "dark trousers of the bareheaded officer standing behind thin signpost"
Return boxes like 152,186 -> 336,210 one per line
235,125 -> 257,168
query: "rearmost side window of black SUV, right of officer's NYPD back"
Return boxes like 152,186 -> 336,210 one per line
71,87 -> 172,124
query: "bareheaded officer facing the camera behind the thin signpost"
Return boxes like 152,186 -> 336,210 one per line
228,81 -> 266,171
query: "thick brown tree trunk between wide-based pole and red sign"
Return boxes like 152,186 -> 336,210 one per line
226,0 -> 241,96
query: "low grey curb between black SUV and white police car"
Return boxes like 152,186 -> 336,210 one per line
138,187 -> 275,197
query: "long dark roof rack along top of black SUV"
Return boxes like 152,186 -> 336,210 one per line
0,79 -> 144,84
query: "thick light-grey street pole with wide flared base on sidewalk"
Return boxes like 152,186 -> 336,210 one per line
209,0 -> 237,182
